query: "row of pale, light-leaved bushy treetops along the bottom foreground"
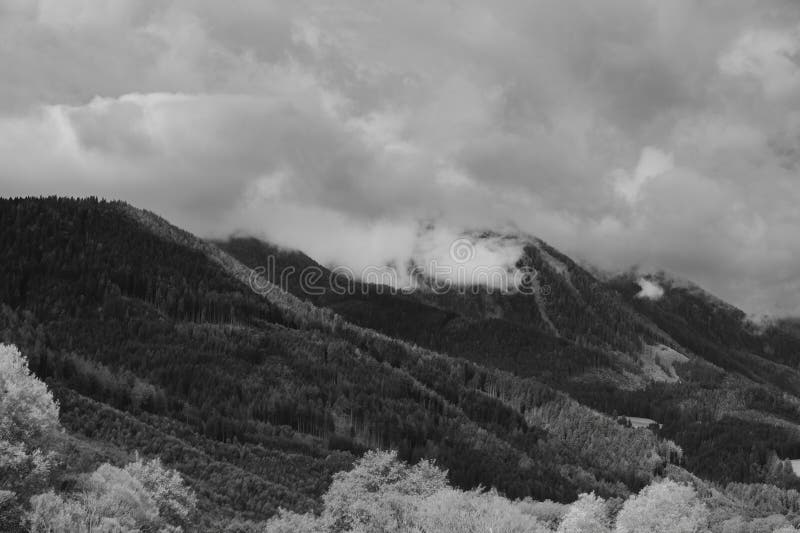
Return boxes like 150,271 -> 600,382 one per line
9,345 -> 800,533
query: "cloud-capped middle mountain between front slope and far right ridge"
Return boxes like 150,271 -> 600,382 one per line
217,238 -> 656,384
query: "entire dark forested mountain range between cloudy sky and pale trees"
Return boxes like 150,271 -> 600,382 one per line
0,197 -> 800,530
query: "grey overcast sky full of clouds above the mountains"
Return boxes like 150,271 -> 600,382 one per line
0,0 -> 800,315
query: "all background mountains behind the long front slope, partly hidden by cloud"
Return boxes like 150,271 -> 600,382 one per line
218,229 -> 800,486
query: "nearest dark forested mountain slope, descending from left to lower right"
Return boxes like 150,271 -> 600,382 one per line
0,198 -> 680,529
